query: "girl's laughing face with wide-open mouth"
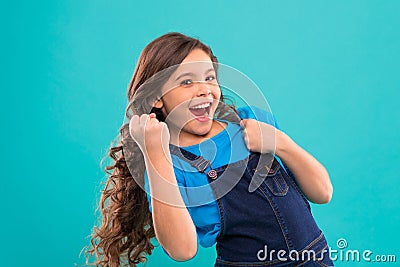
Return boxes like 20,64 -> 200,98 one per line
155,49 -> 221,143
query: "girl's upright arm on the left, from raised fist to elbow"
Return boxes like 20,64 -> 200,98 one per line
130,115 -> 197,261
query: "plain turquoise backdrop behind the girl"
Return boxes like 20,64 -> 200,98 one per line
0,0 -> 400,267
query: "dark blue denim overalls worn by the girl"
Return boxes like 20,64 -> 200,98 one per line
170,145 -> 333,267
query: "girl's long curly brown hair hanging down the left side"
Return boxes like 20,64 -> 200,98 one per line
85,32 -> 237,267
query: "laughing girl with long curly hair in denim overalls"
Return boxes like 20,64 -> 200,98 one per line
88,33 -> 333,267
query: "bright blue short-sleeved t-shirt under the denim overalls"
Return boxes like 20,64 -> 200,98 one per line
144,106 -> 279,247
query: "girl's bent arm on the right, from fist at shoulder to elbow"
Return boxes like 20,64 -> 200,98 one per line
241,119 -> 333,204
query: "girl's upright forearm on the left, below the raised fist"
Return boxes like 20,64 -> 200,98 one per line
145,153 -> 197,261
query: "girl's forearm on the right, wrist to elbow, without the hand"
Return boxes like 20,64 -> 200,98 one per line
275,130 -> 333,204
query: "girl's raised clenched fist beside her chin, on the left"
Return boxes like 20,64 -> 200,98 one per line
129,113 -> 170,155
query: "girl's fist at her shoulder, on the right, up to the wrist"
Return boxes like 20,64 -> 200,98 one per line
240,119 -> 279,153
